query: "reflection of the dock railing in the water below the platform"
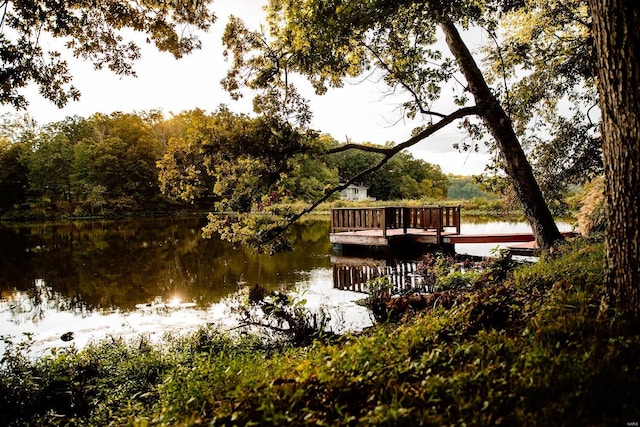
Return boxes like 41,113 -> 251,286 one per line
331,257 -> 429,293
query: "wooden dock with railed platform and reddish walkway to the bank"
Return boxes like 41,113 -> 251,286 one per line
329,206 -> 572,252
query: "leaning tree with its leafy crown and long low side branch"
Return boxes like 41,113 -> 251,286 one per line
223,0 -> 562,248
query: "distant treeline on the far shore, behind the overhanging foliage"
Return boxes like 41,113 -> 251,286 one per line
0,110 -> 486,218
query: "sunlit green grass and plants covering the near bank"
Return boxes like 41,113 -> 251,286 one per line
0,239 -> 640,425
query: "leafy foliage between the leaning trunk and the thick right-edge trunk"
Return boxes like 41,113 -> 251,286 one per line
484,0 -> 602,213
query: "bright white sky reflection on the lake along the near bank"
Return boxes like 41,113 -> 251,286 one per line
0,268 -> 371,357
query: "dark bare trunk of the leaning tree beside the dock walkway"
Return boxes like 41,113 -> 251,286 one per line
440,22 -> 563,249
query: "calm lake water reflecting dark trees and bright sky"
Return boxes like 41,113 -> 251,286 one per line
0,218 -> 567,356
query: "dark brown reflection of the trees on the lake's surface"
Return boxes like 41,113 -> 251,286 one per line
0,218 -> 331,310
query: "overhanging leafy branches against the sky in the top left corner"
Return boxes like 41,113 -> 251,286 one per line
0,0 -> 215,109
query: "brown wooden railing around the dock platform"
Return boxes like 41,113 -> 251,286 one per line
331,205 -> 460,241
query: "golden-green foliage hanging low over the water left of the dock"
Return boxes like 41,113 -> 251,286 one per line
158,108 -> 322,251
